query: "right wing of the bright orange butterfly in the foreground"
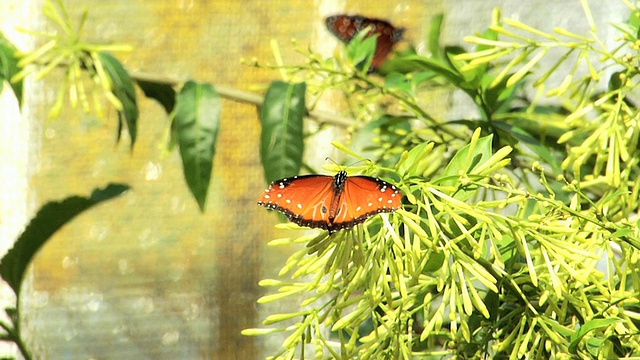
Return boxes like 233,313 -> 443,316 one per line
330,176 -> 402,231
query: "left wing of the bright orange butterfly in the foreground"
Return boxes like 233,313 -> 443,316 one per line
258,175 -> 335,231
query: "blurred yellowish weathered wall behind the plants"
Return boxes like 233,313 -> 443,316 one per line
0,0 -> 628,359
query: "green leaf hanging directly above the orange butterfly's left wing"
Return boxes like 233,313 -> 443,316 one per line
260,81 -> 306,183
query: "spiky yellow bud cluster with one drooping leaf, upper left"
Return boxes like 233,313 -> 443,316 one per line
11,0 -> 137,120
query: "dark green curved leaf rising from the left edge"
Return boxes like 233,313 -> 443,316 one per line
0,184 -> 129,295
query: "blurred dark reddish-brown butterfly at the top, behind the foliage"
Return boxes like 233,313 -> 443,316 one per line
326,15 -> 405,70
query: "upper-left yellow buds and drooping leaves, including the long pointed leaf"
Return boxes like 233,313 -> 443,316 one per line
0,0 -> 221,210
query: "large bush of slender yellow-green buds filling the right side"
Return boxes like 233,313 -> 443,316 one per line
244,2 -> 640,359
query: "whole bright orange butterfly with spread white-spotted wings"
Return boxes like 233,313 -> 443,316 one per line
258,171 -> 402,233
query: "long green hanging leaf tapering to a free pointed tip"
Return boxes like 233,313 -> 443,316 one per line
173,81 -> 222,211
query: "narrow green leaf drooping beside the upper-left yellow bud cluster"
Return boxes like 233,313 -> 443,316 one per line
98,52 -> 139,150
